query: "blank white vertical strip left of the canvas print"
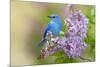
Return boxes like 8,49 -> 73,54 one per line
0,0 -> 10,67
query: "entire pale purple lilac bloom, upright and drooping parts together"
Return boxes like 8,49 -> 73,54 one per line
41,10 -> 88,57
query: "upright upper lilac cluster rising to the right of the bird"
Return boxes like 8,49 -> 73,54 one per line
65,10 -> 88,38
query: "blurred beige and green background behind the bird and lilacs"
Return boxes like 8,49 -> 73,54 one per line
11,1 -> 95,66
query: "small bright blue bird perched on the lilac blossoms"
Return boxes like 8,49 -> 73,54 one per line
37,14 -> 62,47
